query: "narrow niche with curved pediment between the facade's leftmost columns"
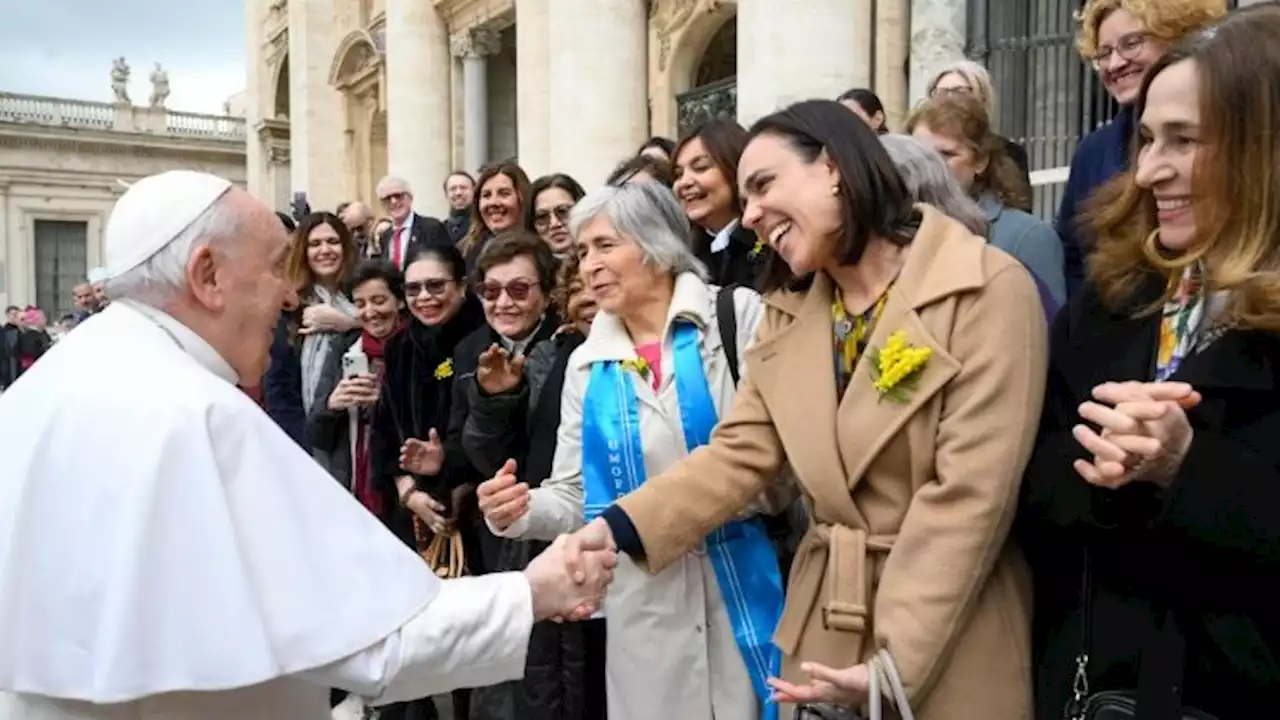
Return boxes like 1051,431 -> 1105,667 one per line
329,31 -> 387,205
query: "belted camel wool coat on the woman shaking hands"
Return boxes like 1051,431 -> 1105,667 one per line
618,205 -> 1047,720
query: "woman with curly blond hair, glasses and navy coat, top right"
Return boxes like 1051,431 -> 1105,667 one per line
1057,0 -> 1226,297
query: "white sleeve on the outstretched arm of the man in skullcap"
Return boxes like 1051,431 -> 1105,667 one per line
298,573 -> 534,705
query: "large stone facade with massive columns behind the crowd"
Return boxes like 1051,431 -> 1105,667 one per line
244,0 -> 921,214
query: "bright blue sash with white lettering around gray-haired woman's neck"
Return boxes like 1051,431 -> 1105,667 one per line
582,322 -> 783,720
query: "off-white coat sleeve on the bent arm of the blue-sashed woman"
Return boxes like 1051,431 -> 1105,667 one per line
486,363 -> 586,542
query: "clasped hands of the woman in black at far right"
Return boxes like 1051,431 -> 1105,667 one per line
1071,382 -> 1201,488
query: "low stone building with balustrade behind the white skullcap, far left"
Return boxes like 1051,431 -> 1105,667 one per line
0,94 -> 247,312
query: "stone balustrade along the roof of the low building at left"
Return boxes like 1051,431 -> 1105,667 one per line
0,92 -> 246,142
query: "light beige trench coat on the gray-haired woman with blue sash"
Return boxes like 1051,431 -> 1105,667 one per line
490,274 -> 783,720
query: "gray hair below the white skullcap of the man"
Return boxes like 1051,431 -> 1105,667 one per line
105,193 -> 241,305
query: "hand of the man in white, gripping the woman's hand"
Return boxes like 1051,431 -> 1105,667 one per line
525,536 -> 618,620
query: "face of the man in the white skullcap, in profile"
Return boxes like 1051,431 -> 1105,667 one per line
206,190 -> 298,384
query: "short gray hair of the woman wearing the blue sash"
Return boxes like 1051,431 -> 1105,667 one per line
568,182 -> 710,282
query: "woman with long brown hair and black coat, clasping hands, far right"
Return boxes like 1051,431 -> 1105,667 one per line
1019,3 -> 1280,720
